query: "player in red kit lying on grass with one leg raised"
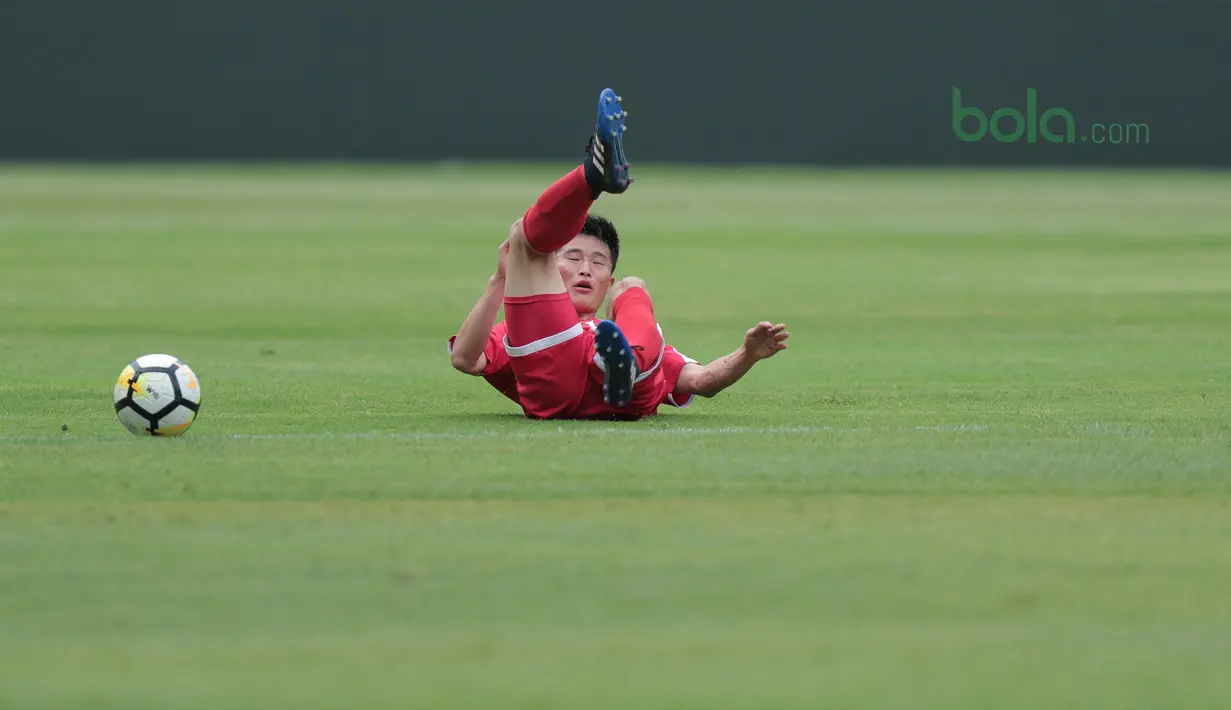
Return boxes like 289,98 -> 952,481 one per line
449,89 -> 789,420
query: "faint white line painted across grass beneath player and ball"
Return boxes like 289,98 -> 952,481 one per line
0,423 -> 1152,443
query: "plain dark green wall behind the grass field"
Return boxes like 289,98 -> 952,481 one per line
0,0 -> 1231,165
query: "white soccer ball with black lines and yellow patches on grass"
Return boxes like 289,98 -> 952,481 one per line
114,354 -> 201,437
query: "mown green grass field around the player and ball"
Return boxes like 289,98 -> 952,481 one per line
0,166 -> 1231,710
